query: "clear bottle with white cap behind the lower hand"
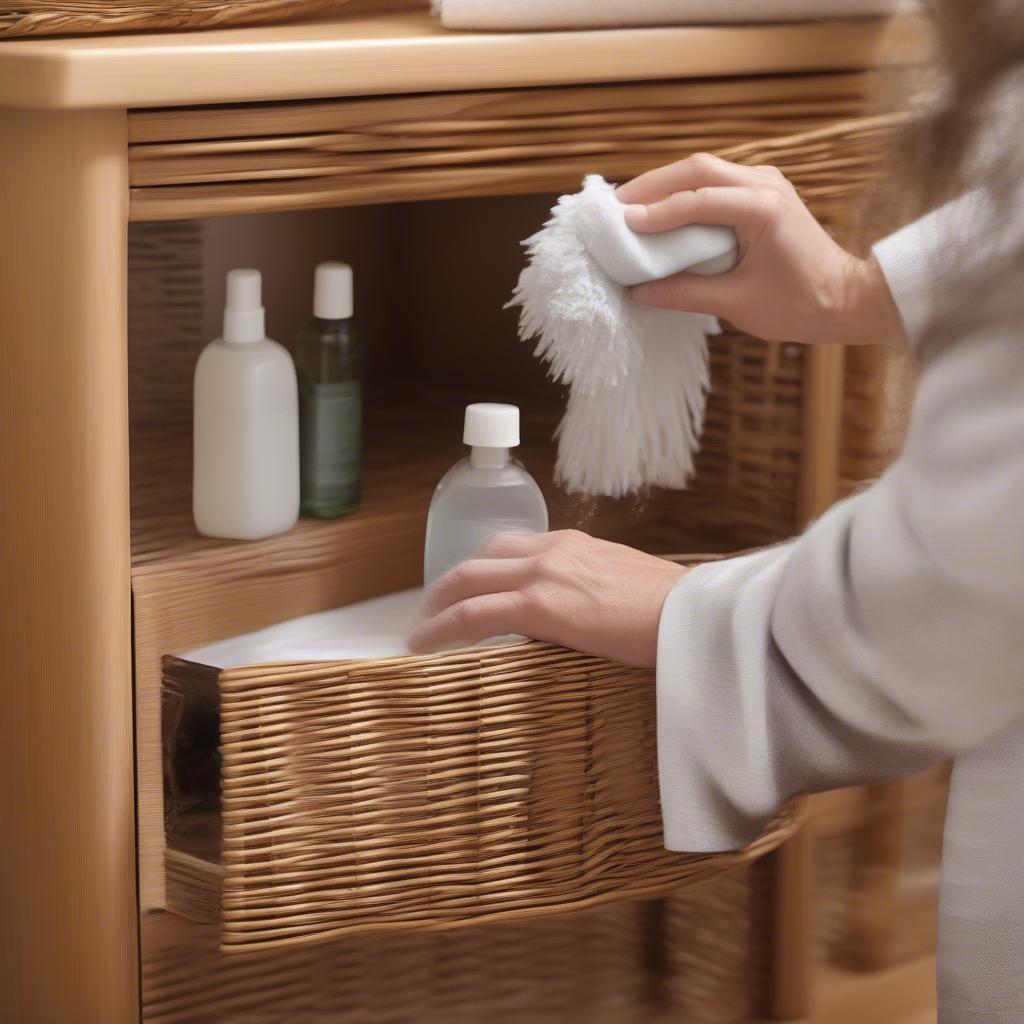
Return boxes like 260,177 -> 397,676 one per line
423,402 -> 548,587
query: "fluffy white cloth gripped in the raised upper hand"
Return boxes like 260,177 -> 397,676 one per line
509,175 -> 737,498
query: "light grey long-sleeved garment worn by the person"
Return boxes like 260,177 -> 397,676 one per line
657,188 -> 1024,1024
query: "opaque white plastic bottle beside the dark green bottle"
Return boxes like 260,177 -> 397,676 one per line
193,269 -> 299,541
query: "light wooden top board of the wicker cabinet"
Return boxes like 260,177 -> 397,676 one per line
0,11 -> 926,109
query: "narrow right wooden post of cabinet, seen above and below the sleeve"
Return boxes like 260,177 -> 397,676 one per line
771,345 -> 844,1020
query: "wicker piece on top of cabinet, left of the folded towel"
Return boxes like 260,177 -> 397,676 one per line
0,0 -> 347,38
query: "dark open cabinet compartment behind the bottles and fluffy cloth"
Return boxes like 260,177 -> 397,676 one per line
129,196 -> 802,589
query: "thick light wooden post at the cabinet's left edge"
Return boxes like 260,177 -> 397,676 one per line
0,110 -> 138,1024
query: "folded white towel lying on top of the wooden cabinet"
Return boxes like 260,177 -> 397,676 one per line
433,0 -> 909,30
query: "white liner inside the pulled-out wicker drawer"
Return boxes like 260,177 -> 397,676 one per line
178,588 -> 423,669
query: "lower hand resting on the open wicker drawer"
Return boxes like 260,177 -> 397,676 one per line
409,529 -> 687,668
